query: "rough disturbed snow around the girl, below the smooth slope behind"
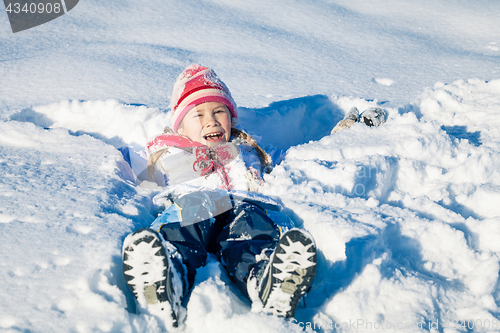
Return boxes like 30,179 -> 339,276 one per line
0,80 -> 500,332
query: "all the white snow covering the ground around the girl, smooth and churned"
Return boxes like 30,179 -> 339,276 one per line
0,0 -> 500,333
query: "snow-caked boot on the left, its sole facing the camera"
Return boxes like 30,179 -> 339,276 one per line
123,228 -> 185,327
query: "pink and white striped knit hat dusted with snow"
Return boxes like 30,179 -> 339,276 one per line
170,64 -> 238,132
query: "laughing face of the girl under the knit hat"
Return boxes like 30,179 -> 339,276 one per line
177,102 -> 231,147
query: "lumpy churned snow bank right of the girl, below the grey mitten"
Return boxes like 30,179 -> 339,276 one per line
264,80 -> 500,332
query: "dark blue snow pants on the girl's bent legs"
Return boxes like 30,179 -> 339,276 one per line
160,201 -> 280,296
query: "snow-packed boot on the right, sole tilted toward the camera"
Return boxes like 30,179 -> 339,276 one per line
247,228 -> 317,318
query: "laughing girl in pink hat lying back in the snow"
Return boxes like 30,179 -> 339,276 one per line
123,65 -> 317,327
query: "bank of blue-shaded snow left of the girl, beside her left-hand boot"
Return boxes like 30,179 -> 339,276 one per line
0,121 -> 153,332
